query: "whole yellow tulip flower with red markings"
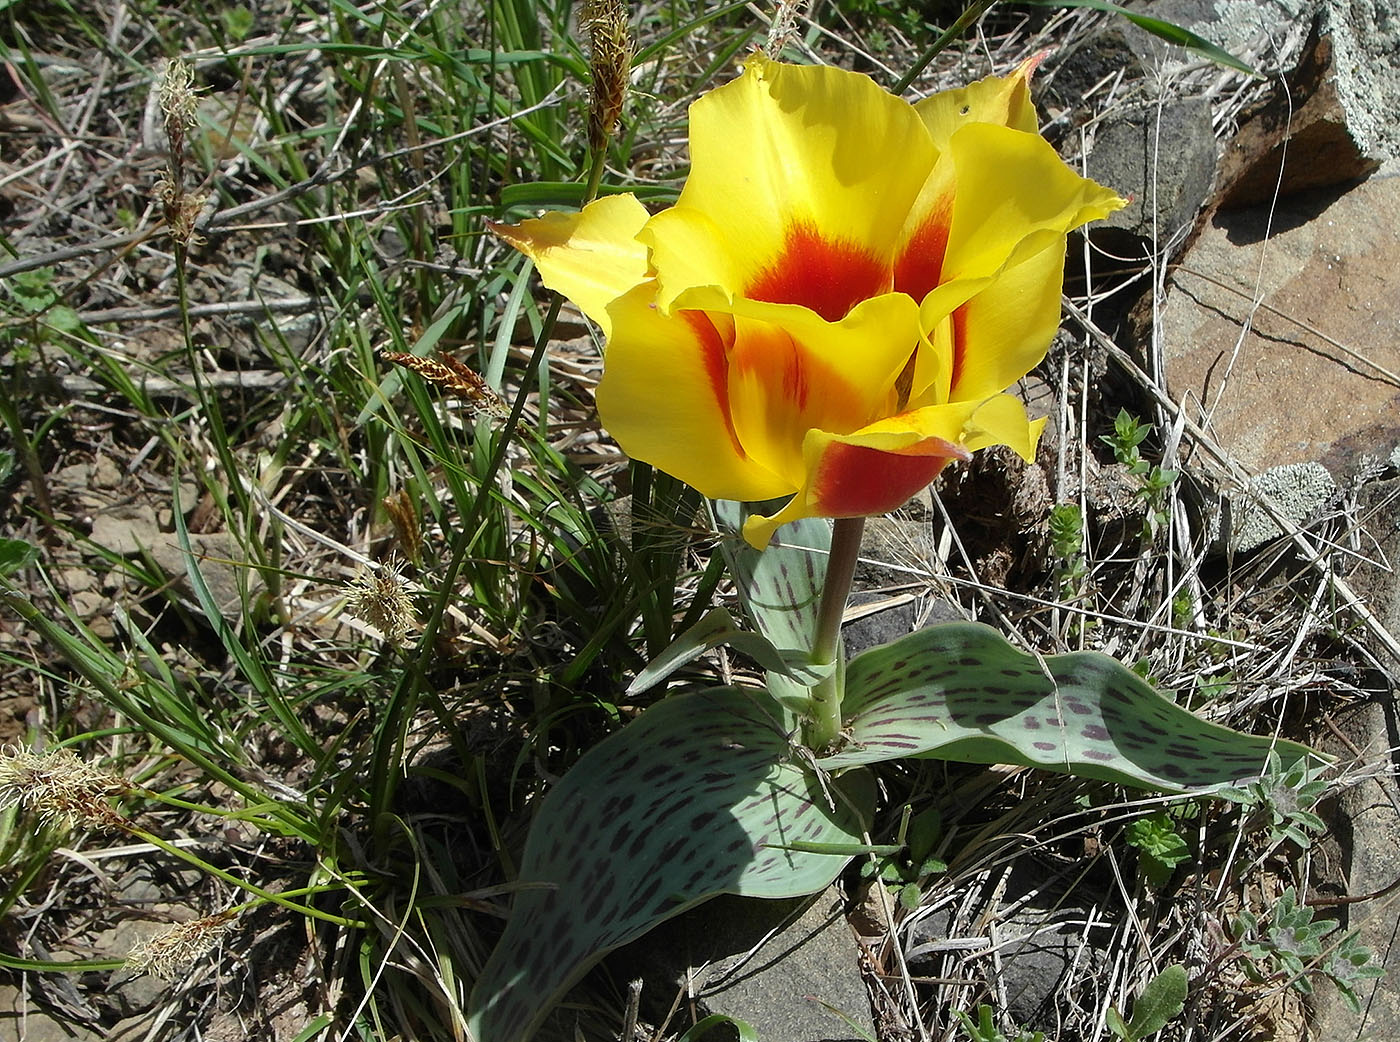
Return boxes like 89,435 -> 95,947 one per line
493,55 -> 1126,548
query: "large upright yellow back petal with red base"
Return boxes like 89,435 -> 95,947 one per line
643,55 -> 934,321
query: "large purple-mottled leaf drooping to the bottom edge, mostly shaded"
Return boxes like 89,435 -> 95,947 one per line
469,688 -> 874,1042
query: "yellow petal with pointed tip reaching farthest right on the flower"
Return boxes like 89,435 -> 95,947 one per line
942,123 -> 1127,280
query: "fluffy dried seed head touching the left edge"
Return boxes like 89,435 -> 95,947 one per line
0,746 -> 132,829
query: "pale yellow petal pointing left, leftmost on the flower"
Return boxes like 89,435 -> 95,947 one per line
489,195 -> 650,336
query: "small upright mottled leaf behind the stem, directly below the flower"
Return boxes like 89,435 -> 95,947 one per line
713,500 -> 832,651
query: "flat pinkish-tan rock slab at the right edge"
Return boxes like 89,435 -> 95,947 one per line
1159,164 -> 1400,476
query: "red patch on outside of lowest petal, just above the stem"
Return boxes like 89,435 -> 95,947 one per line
812,438 -> 972,517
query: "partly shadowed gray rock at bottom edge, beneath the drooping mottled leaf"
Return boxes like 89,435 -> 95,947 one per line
609,888 -> 875,1042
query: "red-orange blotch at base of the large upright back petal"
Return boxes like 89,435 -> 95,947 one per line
743,221 -> 890,322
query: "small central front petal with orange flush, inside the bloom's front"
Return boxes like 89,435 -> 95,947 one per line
729,294 -> 918,492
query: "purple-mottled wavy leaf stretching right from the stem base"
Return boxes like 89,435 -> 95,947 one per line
818,622 -> 1322,793
